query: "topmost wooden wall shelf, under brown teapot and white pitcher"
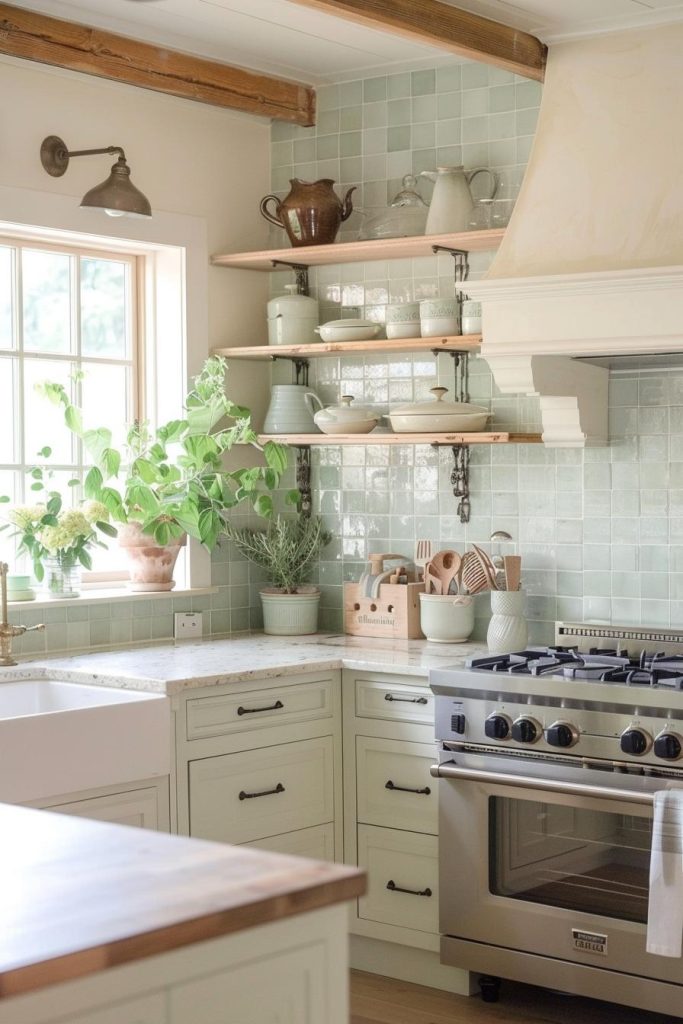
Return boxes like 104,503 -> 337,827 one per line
211,228 -> 505,270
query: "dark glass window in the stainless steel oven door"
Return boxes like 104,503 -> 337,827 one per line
488,797 -> 652,923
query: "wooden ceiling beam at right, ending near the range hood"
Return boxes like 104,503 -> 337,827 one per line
292,0 -> 547,82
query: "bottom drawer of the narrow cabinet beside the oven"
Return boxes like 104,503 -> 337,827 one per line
358,825 -> 438,934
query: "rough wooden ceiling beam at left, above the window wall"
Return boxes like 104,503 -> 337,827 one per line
0,3 -> 315,125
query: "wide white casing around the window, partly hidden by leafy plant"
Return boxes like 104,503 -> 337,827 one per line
0,177 -> 211,600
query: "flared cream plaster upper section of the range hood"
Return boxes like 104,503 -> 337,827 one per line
486,25 -> 683,279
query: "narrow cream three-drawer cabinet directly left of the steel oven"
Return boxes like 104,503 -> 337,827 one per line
343,670 -> 439,950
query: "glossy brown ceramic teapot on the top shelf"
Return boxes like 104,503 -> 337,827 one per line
261,178 -> 355,246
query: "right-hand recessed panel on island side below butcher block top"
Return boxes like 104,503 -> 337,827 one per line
169,945 -> 329,1024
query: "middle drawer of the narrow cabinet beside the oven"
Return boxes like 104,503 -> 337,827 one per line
355,736 -> 438,836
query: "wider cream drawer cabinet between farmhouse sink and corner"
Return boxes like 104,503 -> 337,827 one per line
174,672 -> 342,859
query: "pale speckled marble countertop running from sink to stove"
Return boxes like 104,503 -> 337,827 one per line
0,633 -> 486,696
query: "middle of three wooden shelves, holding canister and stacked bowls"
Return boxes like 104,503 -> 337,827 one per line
213,334 -> 481,359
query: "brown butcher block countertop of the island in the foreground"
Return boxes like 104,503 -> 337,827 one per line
0,804 -> 365,999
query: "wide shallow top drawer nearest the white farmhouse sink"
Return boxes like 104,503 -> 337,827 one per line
187,676 -> 333,739
